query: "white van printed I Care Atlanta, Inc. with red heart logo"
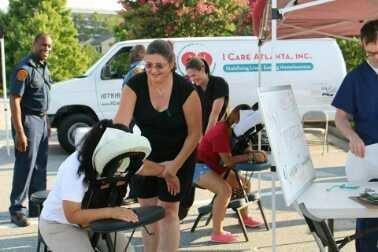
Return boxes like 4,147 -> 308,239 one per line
48,37 -> 346,151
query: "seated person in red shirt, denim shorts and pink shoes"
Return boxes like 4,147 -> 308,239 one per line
193,104 -> 266,243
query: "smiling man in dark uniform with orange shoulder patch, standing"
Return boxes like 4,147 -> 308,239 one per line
9,33 -> 52,227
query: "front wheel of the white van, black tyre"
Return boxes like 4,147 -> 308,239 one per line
58,114 -> 96,153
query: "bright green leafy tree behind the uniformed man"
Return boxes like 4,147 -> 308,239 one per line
0,0 -> 93,81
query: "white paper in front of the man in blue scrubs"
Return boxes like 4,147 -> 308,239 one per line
345,144 -> 378,182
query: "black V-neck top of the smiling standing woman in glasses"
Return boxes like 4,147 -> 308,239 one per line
129,73 -> 194,162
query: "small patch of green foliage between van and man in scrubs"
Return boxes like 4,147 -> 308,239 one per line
337,38 -> 365,72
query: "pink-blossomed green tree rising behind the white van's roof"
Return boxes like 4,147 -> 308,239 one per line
115,0 -> 250,40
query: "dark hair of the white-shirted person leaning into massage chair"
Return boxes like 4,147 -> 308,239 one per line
77,119 -> 130,184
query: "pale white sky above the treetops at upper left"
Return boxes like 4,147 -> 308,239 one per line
0,0 -> 122,12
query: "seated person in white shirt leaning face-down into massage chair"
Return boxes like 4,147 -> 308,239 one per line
39,120 -> 179,252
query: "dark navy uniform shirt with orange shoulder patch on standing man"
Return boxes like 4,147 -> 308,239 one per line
10,54 -> 52,114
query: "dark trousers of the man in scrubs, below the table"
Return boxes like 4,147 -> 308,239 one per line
356,179 -> 378,252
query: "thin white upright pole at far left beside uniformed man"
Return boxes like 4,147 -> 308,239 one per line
0,37 -> 10,156
